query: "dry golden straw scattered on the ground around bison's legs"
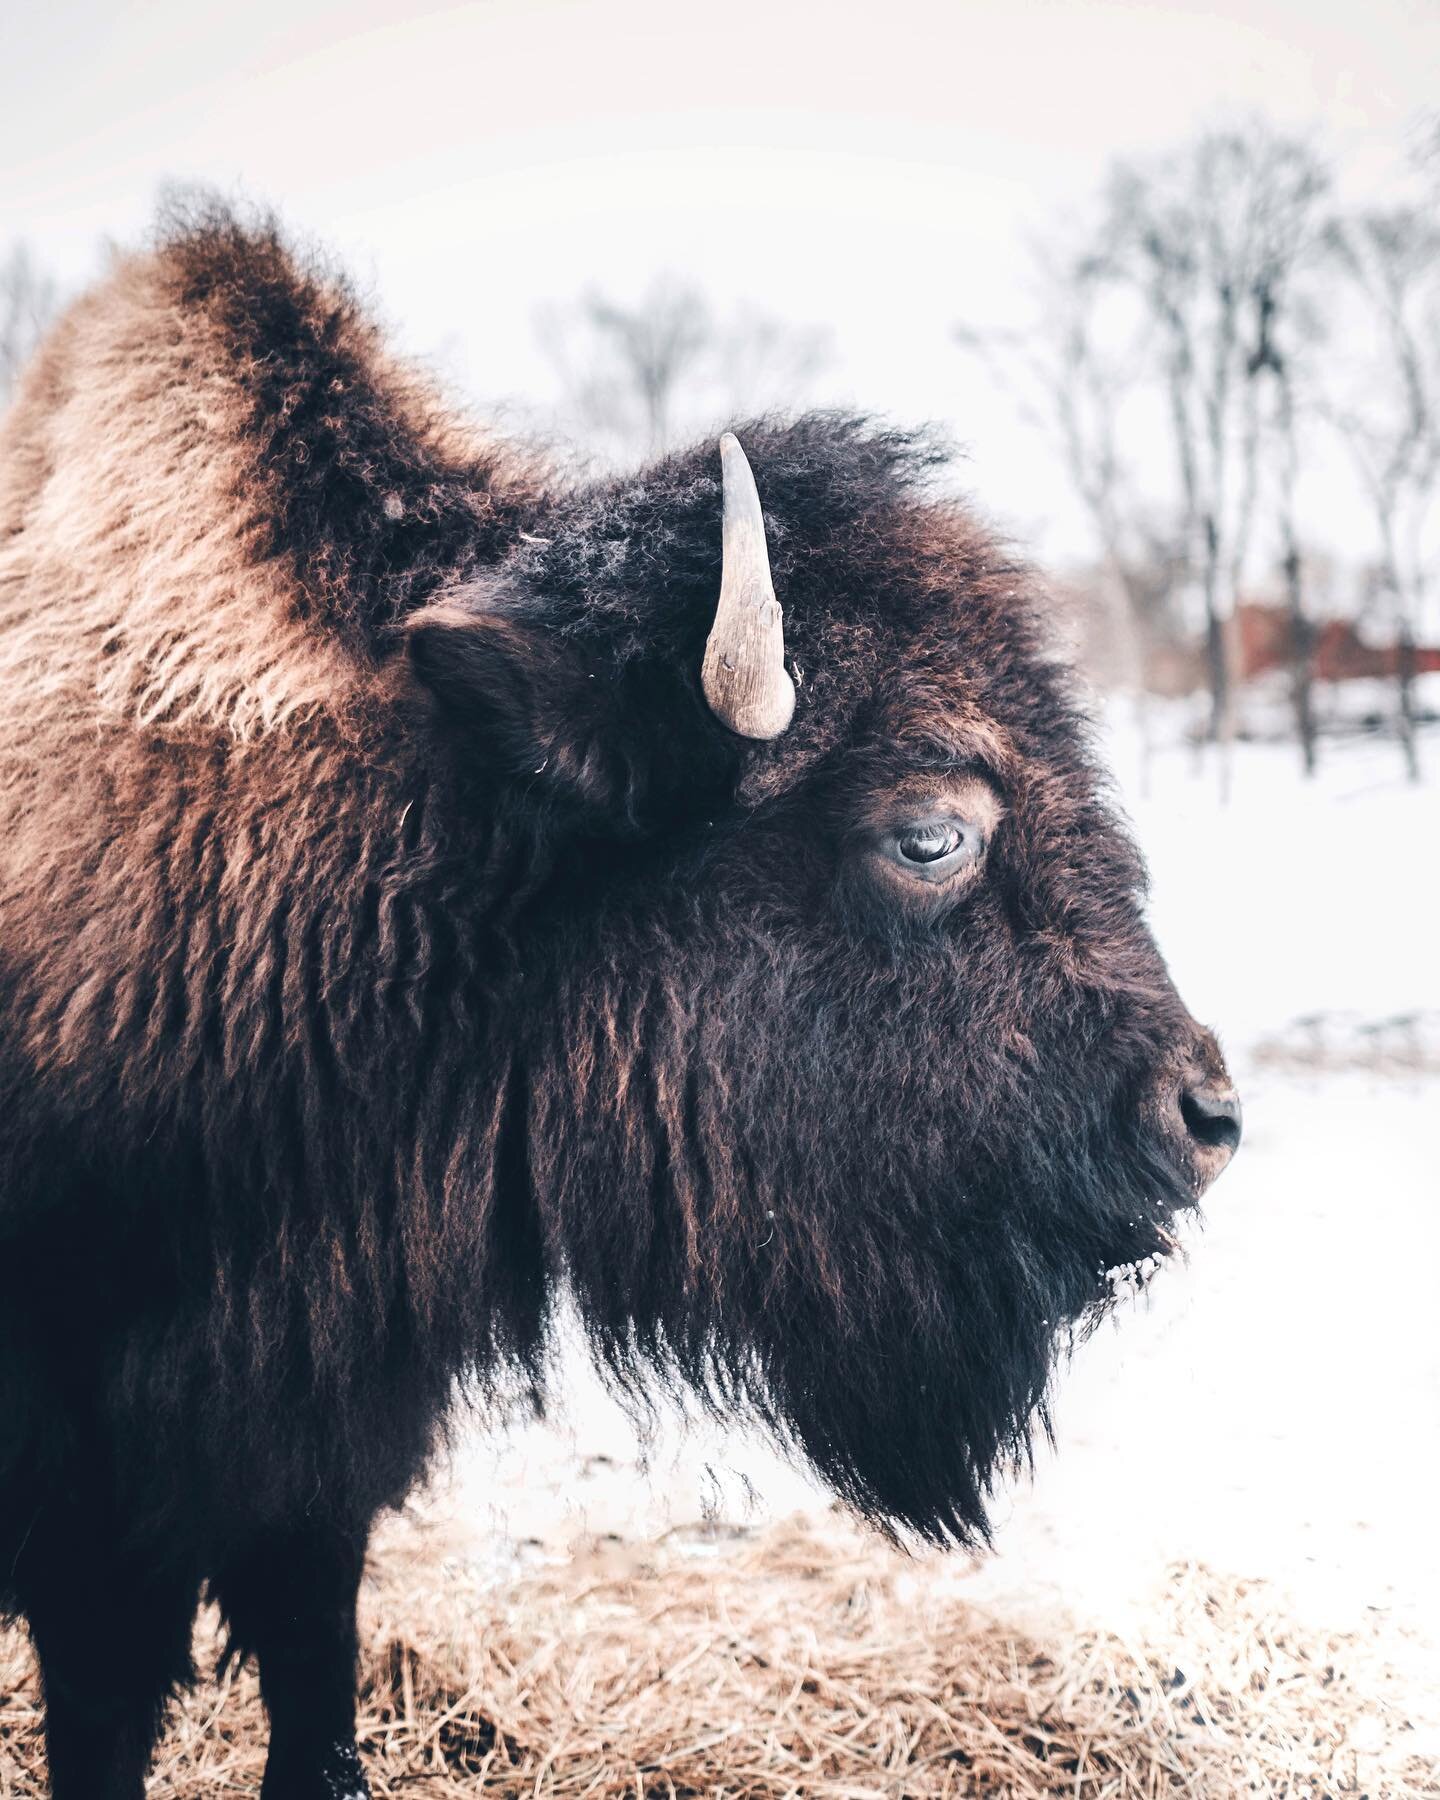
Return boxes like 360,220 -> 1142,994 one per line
0,1525 -> 1440,1800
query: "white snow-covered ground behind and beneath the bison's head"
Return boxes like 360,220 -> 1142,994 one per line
421,712 -> 1440,1670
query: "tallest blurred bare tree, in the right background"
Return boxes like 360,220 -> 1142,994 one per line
1105,124 -> 1327,787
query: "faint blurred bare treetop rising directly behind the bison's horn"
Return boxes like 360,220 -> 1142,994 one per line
535,275 -> 832,461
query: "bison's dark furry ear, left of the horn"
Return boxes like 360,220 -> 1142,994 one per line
405,601 -> 702,833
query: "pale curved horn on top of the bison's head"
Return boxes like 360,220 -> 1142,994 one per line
700,432 -> 796,738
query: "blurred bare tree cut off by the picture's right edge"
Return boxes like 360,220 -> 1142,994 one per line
1327,205 -> 1440,781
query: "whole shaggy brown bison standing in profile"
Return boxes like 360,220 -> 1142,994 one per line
0,209 -> 1240,1800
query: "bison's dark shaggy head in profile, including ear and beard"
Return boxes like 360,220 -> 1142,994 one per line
410,419 -> 1238,1539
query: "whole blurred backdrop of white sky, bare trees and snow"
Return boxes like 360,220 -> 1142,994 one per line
0,0 -> 1440,1793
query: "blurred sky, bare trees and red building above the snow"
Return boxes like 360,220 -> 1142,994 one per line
0,0 -> 1440,787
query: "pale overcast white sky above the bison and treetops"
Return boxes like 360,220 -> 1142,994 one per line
0,0 -> 1440,553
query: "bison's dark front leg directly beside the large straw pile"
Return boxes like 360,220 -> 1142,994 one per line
211,1526 -> 369,1800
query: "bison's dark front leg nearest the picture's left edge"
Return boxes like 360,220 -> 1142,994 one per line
16,1521 -> 198,1800
